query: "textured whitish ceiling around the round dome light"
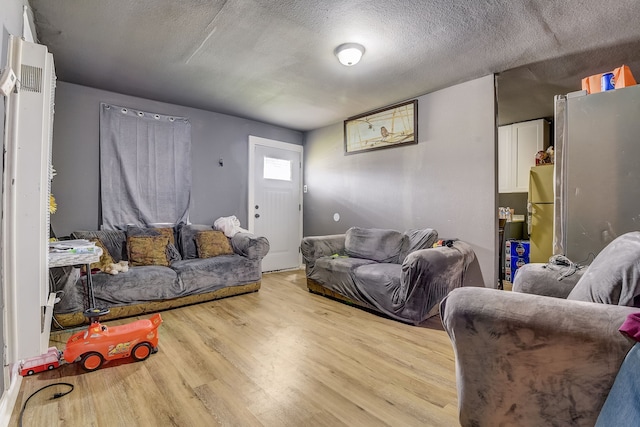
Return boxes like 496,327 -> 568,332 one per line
29,0 -> 640,131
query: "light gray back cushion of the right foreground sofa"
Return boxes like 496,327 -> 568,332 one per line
567,231 -> 640,307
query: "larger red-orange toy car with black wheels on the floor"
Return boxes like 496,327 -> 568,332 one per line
63,313 -> 162,371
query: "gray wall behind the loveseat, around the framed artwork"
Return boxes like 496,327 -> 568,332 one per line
304,75 -> 497,287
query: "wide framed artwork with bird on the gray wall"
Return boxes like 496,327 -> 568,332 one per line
344,99 -> 418,154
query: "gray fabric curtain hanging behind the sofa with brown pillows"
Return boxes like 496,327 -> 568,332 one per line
100,103 -> 191,230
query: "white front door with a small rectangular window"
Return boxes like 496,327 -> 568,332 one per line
248,136 -> 302,271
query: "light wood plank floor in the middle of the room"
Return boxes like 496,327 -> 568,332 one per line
11,271 -> 458,427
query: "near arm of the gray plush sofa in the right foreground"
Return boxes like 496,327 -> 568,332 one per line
440,288 -> 638,427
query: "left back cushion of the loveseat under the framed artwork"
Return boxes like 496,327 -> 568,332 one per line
344,227 -> 405,263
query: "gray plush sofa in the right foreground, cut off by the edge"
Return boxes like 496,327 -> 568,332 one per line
440,232 -> 640,427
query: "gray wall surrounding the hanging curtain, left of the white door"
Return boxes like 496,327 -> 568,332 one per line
51,82 -> 303,236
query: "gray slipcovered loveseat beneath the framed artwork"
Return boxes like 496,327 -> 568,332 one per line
301,227 -> 484,324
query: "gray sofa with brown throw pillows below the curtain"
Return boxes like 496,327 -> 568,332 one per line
50,224 -> 269,327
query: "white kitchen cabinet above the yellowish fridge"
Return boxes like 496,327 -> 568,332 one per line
498,119 -> 549,193
